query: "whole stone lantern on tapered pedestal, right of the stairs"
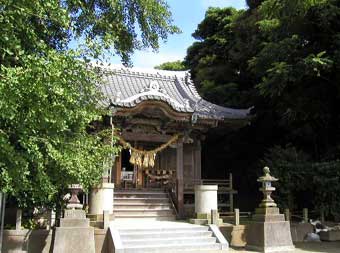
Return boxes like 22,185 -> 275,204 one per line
246,167 -> 295,252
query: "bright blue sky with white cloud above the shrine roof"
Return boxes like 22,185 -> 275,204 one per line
111,0 -> 246,68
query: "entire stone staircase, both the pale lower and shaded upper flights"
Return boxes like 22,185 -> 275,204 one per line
110,189 -> 228,253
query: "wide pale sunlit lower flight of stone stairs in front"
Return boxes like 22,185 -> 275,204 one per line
110,222 -> 228,253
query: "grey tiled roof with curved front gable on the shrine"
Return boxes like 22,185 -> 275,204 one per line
99,67 -> 250,120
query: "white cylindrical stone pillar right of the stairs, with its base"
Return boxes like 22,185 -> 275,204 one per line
190,185 -> 222,225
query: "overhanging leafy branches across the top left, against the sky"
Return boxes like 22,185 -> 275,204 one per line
0,0 -> 179,64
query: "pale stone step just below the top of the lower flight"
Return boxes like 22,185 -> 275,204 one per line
119,230 -> 212,241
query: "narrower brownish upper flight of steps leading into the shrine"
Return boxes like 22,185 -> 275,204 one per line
113,189 -> 176,221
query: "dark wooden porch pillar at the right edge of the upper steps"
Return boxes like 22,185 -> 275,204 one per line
176,140 -> 184,218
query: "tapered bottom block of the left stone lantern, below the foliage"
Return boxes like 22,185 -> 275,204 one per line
53,227 -> 95,253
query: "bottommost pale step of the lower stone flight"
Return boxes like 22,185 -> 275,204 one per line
124,243 -> 220,253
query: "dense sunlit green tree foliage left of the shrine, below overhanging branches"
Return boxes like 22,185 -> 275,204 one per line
0,51 -> 117,208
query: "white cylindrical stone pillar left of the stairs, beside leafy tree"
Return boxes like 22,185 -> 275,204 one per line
89,183 -> 114,215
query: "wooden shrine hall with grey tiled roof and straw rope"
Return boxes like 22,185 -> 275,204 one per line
100,67 -> 250,217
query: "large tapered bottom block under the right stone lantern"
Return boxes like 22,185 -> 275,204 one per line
246,221 -> 295,253
